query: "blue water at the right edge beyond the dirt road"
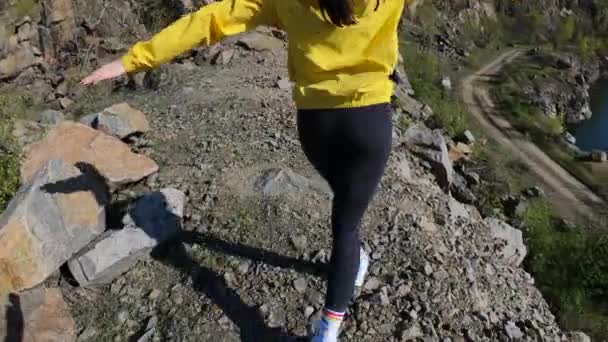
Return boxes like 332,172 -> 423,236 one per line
574,79 -> 608,151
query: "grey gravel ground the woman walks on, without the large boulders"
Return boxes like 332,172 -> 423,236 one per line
0,28 -> 588,341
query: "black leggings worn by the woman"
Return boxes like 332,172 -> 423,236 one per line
298,104 -> 392,312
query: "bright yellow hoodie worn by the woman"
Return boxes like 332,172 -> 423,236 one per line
122,0 -> 406,109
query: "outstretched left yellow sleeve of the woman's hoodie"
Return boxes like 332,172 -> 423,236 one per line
122,0 -> 278,73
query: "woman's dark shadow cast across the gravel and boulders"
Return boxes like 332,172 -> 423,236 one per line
39,163 -> 325,342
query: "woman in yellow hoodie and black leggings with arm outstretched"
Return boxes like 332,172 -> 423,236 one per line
82,0 -> 406,342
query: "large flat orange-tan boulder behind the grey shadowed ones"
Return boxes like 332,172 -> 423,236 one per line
21,121 -> 158,188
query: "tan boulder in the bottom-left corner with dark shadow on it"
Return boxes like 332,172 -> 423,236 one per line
0,288 -> 77,342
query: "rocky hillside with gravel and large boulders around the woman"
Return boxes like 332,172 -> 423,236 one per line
0,0 -> 589,341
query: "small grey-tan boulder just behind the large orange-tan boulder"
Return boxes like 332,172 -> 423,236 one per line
80,103 -> 150,139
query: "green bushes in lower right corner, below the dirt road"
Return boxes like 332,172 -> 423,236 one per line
523,200 -> 608,340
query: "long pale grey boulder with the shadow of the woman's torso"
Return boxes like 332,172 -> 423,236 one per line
68,189 -> 186,286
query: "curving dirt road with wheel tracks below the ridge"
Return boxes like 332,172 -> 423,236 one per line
461,49 -> 604,219
